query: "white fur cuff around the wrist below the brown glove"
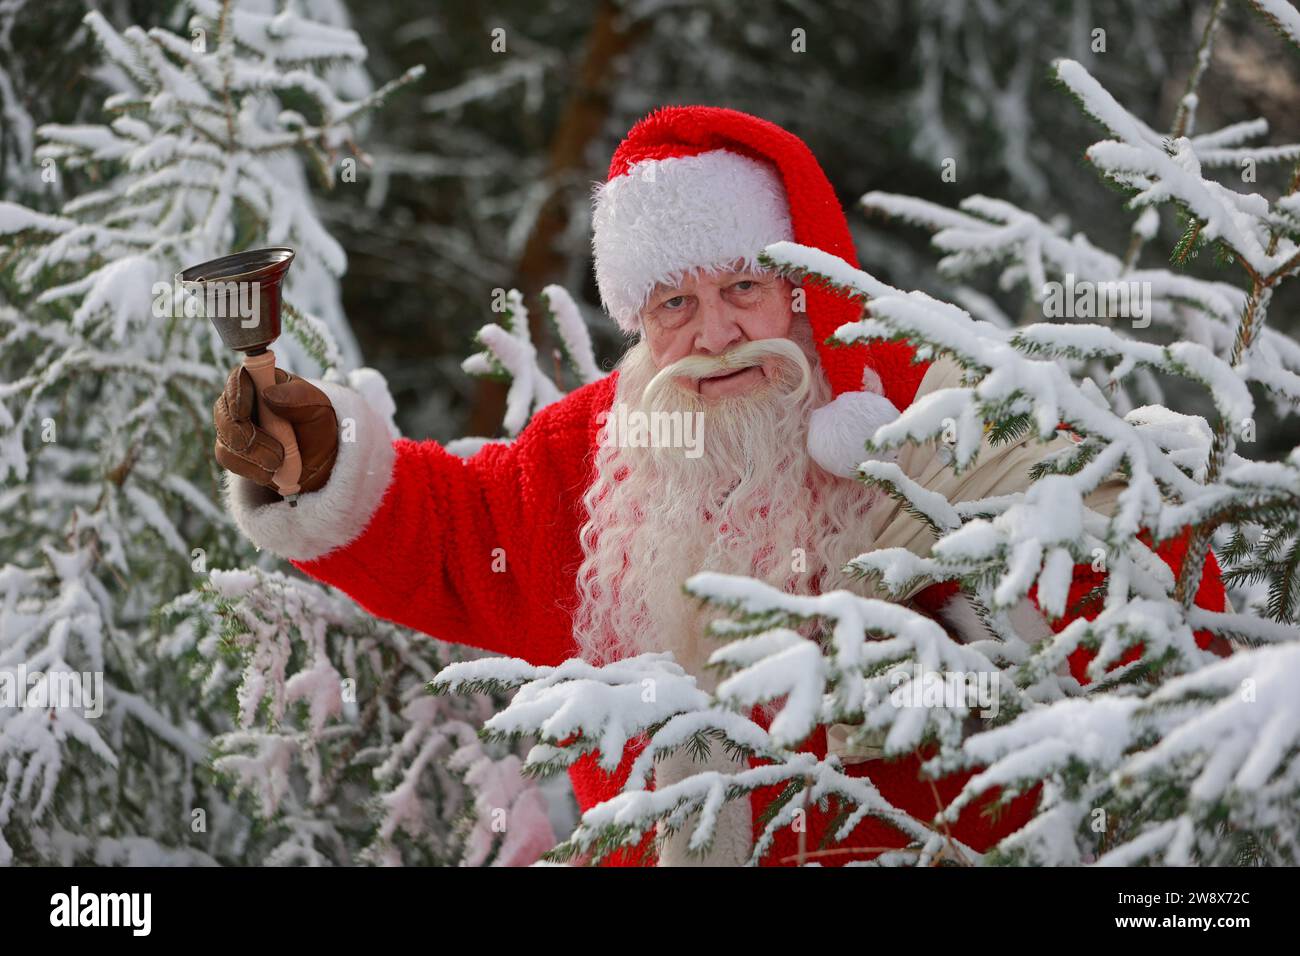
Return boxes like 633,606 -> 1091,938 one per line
226,380 -> 395,561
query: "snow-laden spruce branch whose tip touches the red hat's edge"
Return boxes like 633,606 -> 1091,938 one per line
764,243 -> 1237,580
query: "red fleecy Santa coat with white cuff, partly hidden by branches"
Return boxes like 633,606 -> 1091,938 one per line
220,375 -> 1223,865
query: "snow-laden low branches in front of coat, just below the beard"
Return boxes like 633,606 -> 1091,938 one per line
430,574 -> 1024,862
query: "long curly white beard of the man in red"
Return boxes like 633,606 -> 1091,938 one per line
575,317 -> 875,689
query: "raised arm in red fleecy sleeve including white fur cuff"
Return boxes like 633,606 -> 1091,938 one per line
218,366 -> 608,663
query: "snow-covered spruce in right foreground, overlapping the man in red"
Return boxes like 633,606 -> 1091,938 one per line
432,0 -> 1300,865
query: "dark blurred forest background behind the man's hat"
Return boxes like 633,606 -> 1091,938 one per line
0,0 -> 1300,447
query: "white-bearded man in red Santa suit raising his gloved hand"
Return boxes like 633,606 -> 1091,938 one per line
215,107 -> 1223,864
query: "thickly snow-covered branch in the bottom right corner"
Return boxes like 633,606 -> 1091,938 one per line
945,635 -> 1300,866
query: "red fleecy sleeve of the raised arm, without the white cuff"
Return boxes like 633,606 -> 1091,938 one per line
293,376 -> 612,665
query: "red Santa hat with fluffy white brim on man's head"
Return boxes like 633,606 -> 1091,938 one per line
592,107 -> 926,426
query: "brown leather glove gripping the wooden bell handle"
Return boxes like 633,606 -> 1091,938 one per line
212,365 -> 338,494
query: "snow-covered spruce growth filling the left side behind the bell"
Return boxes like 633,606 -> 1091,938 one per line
0,0 -> 549,864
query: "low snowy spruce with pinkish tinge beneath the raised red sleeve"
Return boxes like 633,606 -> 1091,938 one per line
157,568 -> 555,866
